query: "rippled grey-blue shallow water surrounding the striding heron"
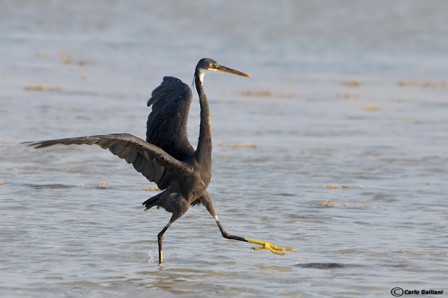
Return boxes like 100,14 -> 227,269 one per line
0,1 -> 448,297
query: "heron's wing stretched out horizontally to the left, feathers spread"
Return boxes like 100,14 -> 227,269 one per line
27,133 -> 190,189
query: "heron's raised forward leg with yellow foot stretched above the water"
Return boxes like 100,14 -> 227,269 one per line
202,192 -> 294,255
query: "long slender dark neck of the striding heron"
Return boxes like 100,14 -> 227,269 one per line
195,74 -> 212,175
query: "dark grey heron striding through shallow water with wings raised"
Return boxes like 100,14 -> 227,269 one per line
25,58 -> 293,264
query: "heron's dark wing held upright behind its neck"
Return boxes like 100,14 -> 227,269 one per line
146,77 -> 194,160
